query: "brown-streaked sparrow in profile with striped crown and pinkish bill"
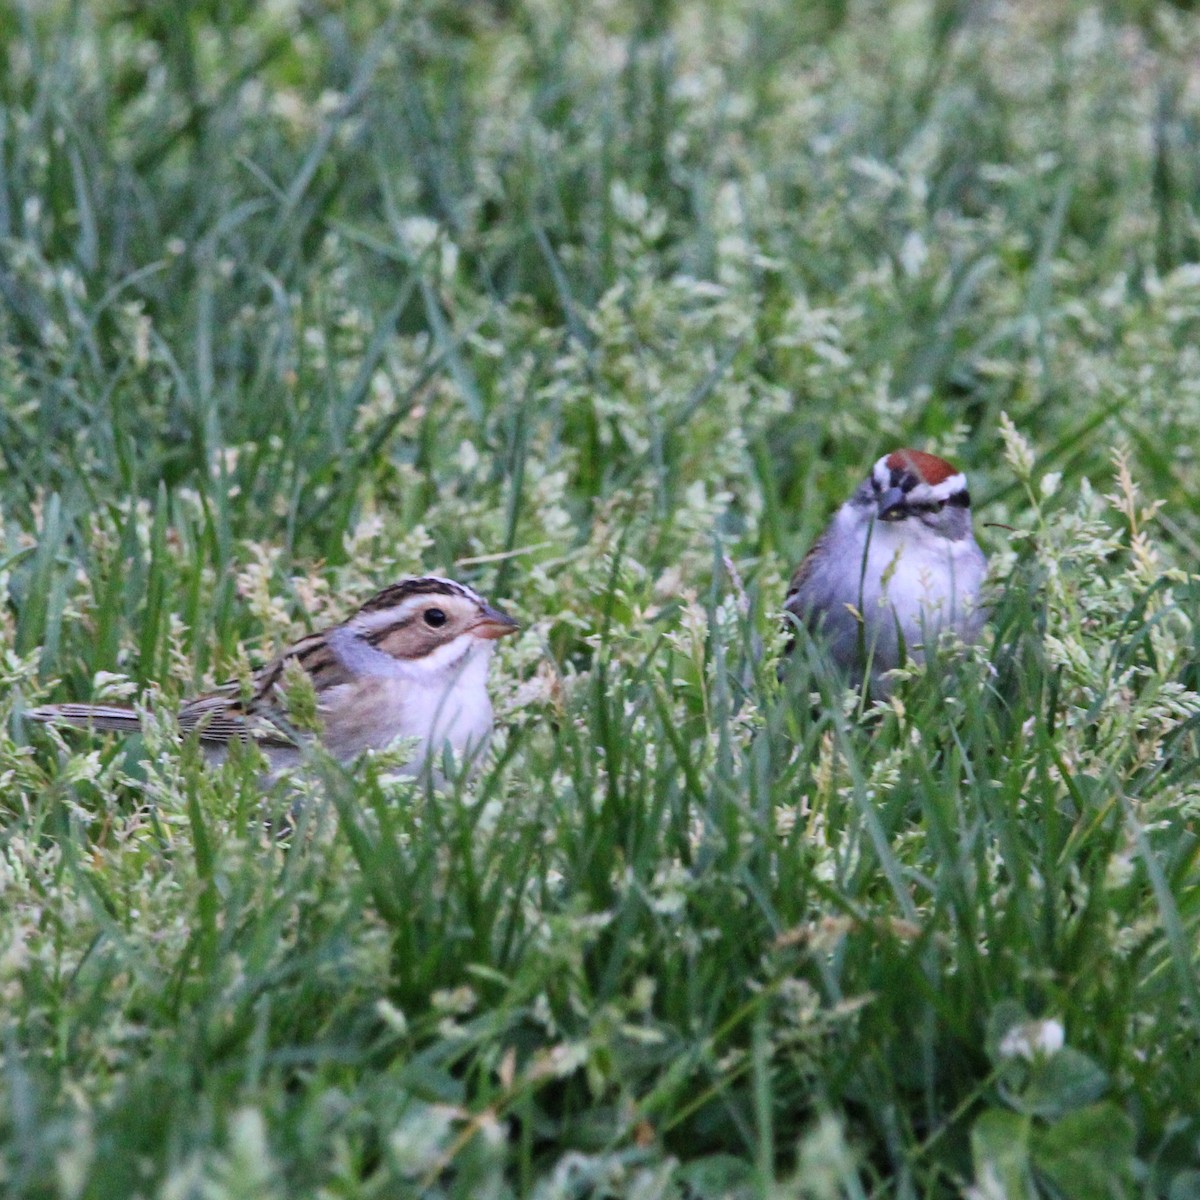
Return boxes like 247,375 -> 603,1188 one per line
28,576 -> 517,772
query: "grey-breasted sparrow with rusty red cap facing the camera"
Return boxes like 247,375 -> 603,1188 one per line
785,450 -> 988,695
